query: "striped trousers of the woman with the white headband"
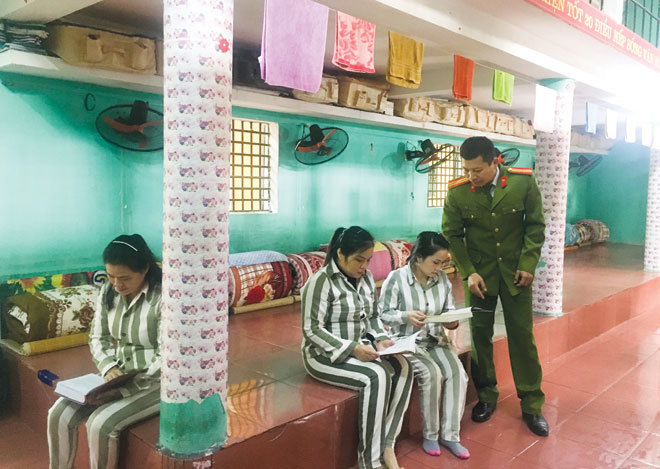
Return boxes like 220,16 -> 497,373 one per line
48,386 -> 160,469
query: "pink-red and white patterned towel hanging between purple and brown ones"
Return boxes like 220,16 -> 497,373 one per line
332,11 -> 376,73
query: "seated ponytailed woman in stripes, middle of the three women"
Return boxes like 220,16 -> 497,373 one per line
302,226 -> 412,469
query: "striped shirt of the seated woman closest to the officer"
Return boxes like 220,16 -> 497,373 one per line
379,264 -> 456,345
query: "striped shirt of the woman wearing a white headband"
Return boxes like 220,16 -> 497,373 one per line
89,282 -> 161,394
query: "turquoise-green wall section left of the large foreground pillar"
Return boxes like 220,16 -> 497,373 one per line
0,74 -> 163,280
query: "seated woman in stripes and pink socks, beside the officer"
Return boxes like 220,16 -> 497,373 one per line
380,231 -> 470,459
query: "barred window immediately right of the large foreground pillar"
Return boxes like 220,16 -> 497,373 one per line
230,119 -> 279,213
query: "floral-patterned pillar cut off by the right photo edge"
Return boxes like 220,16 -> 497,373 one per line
644,148 -> 660,272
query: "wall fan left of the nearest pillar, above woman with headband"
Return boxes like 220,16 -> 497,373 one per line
96,101 -> 163,151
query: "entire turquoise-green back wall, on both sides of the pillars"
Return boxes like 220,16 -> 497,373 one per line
0,74 -> 648,281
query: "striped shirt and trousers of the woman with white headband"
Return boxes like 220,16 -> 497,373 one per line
48,282 -> 161,469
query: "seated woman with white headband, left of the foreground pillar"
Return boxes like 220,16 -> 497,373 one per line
48,234 -> 162,469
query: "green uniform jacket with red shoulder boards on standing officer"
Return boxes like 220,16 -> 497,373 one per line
442,167 -> 545,295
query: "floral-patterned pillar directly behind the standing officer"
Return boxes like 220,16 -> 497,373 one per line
533,79 -> 575,315
